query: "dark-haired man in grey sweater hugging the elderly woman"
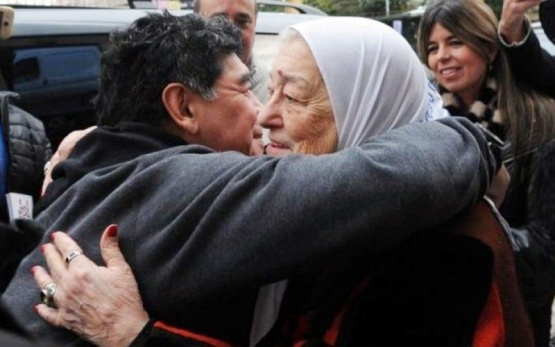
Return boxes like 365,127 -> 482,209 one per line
2,13 -> 496,345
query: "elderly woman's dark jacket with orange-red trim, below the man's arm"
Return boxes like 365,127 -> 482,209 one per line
135,202 -> 534,346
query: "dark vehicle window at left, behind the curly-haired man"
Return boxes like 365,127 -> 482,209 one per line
6,45 -> 101,148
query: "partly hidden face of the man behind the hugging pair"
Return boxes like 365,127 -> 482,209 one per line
199,0 -> 256,66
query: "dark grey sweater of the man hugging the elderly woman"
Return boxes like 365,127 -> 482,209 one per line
3,118 -> 495,345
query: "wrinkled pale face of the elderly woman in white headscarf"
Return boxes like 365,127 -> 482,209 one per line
258,39 -> 338,156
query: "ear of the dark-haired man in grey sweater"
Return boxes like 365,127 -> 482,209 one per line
162,83 -> 198,135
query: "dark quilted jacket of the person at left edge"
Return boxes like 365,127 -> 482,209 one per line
0,92 -> 52,221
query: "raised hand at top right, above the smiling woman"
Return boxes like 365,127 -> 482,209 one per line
499,0 -> 541,43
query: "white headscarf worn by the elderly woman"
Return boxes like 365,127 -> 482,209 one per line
291,17 -> 445,150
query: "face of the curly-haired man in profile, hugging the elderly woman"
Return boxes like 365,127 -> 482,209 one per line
191,54 -> 262,154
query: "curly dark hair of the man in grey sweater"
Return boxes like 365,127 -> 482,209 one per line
96,11 -> 242,126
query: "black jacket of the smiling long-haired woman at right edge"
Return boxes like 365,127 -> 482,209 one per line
501,141 -> 555,308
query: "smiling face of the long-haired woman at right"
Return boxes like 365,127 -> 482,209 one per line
427,23 -> 489,106
